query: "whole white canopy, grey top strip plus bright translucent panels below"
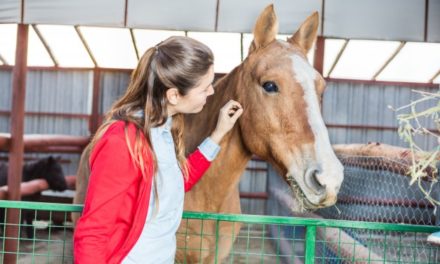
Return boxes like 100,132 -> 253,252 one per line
0,0 -> 440,83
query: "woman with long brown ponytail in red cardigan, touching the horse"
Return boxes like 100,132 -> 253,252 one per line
74,37 -> 243,264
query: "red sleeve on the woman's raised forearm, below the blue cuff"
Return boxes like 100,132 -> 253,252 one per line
185,149 -> 211,192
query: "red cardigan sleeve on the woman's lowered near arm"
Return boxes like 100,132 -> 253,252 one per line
74,135 -> 138,264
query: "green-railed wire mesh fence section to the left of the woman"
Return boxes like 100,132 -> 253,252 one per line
0,201 -> 81,263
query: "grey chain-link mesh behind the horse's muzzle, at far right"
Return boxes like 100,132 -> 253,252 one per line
312,156 -> 440,263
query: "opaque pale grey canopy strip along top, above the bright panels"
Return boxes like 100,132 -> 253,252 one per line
0,0 -> 440,42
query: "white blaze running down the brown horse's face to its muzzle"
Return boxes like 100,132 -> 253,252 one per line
291,55 -> 343,194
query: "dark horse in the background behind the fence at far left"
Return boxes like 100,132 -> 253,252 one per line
0,156 -> 67,238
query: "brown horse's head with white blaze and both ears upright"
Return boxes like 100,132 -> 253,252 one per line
237,5 -> 343,209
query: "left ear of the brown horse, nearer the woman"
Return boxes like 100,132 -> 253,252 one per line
249,4 -> 278,53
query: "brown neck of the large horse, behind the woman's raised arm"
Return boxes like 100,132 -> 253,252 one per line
185,68 -> 251,211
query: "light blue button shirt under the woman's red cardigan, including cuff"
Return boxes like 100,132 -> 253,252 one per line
122,117 -> 220,264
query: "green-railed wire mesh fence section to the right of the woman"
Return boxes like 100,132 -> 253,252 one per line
177,212 -> 440,264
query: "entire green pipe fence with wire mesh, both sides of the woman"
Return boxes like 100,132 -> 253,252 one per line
0,200 -> 440,264
